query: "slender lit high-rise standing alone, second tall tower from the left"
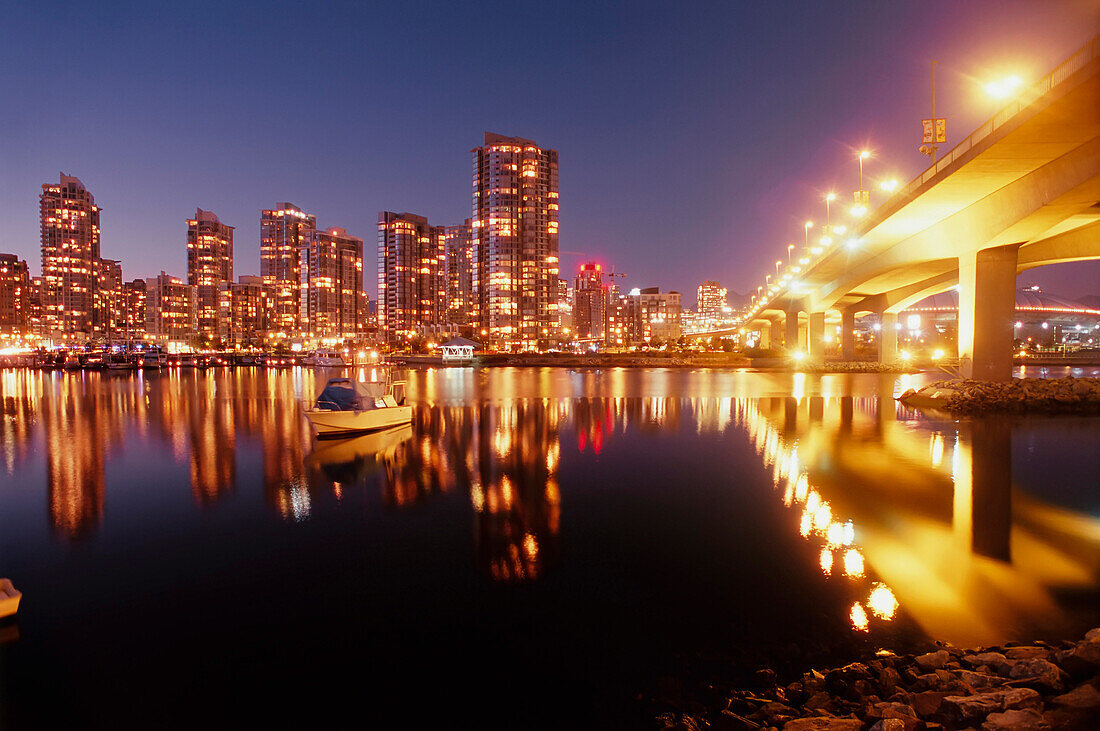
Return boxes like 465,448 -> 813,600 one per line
187,208 -> 234,337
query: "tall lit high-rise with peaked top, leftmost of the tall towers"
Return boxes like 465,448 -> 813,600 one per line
39,173 -> 100,340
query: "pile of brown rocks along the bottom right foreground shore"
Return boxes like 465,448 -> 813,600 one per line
657,628 -> 1100,731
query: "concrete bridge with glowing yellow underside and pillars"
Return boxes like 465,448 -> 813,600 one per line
743,35 -> 1100,380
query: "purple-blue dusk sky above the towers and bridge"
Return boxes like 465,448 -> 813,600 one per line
0,0 -> 1100,306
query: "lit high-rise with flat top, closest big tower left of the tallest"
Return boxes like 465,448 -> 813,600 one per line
378,211 -> 447,342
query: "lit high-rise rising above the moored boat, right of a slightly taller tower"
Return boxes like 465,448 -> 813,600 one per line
298,228 -> 365,340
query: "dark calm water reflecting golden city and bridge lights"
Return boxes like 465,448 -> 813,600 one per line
0,368 -> 1100,728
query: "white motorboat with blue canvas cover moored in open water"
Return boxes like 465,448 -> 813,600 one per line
304,374 -> 413,439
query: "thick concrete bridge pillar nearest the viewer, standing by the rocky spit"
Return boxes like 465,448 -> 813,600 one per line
958,244 -> 1020,380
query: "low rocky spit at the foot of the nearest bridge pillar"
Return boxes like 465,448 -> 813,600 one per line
898,376 -> 1100,413
